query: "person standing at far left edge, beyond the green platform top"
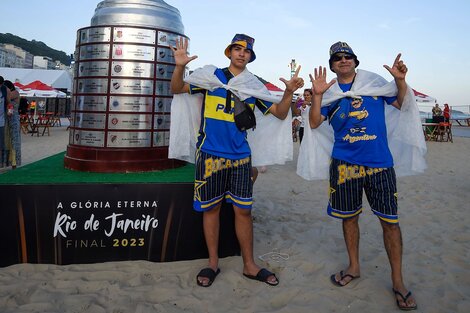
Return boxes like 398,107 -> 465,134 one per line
4,80 -> 21,169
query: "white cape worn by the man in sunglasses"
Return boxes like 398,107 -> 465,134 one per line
297,70 -> 427,180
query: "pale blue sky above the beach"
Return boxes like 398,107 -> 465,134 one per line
0,0 -> 470,106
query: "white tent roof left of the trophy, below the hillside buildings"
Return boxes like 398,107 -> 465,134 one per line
0,67 -> 73,91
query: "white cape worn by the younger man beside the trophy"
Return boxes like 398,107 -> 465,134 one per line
168,65 -> 293,166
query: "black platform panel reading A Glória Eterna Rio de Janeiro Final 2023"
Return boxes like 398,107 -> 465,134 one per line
0,182 -> 239,266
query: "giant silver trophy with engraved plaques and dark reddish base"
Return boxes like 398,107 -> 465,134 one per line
65,0 -> 185,172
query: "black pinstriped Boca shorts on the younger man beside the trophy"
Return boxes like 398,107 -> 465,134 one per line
194,151 -> 253,212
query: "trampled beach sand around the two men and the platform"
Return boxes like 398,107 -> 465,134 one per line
0,123 -> 470,313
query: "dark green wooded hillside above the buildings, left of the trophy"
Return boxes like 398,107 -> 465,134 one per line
0,33 -> 71,65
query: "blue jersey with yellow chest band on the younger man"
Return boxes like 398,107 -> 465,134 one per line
189,69 -> 272,160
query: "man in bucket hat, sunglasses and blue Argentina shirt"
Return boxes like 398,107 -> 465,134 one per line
309,42 -> 422,310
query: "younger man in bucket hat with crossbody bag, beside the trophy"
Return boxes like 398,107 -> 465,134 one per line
169,34 -> 303,287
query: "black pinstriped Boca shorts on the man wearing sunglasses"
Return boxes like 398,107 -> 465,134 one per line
328,159 -> 398,224
